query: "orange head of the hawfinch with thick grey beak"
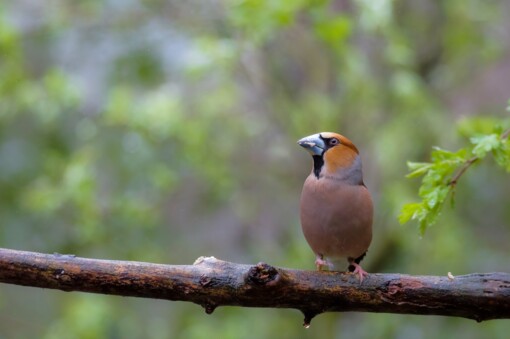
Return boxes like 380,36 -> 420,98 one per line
298,132 -> 362,181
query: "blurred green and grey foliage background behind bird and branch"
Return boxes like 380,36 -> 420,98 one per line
0,0 -> 510,338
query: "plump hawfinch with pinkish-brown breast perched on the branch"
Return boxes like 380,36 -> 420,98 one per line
298,132 -> 373,283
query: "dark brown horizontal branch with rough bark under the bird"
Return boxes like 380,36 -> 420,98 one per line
0,249 -> 510,326
